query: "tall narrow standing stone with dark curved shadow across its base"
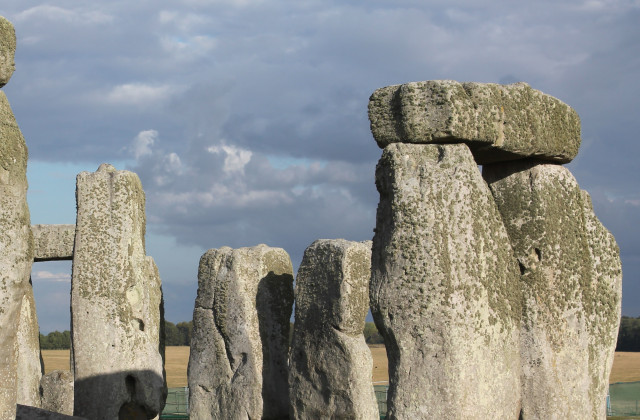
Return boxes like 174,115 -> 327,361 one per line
71,164 -> 166,419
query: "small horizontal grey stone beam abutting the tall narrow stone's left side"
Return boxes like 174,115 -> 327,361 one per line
31,225 -> 76,261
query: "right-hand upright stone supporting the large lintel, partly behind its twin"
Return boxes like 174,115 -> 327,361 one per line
483,161 -> 622,419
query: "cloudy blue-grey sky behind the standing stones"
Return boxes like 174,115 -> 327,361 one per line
0,0 -> 640,333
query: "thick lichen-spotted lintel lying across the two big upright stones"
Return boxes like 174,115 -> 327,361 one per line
369,80 -> 580,164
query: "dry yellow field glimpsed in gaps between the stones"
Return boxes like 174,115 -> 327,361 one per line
42,344 -> 640,388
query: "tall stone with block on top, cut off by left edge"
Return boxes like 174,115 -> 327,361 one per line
0,16 -> 42,419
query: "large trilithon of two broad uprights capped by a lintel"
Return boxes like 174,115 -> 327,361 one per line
369,81 -> 622,420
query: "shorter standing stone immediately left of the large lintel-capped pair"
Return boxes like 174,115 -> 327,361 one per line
289,239 -> 380,420
